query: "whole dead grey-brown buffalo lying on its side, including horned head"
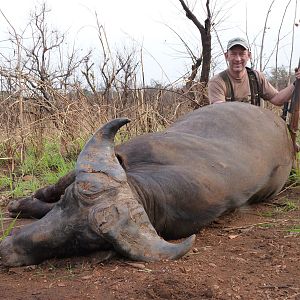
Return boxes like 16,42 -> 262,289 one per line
0,103 -> 293,266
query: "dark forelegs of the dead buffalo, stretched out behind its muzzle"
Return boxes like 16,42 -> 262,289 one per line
8,171 -> 75,219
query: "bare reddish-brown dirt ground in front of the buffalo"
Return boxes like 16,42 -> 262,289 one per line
0,187 -> 300,300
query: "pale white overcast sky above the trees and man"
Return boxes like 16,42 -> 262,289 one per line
0,0 -> 300,83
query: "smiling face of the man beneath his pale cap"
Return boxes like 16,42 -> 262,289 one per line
225,45 -> 251,72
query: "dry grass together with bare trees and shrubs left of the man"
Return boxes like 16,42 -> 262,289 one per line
0,5 -> 203,173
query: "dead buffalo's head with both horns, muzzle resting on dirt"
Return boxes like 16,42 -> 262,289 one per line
0,118 -> 195,266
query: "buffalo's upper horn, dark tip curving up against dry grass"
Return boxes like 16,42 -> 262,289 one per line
76,118 -> 130,195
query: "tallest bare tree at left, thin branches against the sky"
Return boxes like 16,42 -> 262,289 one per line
23,3 -> 89,108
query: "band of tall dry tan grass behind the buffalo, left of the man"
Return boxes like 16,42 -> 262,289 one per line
0,81 -> 204,172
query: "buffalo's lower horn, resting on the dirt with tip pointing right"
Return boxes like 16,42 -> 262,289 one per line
89,188 -> 195,261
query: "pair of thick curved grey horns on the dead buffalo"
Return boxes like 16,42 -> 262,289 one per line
75,118 -> 195,261
